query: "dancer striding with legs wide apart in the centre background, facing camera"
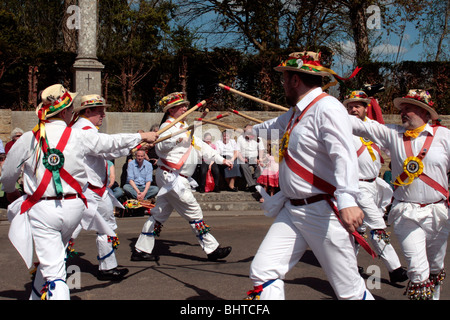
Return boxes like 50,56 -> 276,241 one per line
131,92 -> 232,261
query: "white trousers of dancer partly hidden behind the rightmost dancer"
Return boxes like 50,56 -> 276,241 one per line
357,181 -> 401,272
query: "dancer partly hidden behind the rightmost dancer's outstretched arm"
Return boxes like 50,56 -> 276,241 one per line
343,90 -> 408,283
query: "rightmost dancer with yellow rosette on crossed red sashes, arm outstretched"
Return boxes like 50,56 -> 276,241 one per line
352,89 -> 450,299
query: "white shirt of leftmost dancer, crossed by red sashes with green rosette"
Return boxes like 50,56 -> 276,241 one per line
1,119 -> 141,197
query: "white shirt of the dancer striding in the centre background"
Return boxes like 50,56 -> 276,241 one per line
155,117 -> 224,177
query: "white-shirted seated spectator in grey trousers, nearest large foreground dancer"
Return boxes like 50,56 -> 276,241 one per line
237,125 -> 265,192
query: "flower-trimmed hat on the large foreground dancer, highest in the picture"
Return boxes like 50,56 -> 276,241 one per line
274,51 -> 331,77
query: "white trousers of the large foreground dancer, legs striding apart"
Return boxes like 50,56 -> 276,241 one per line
250,201 -> 373,300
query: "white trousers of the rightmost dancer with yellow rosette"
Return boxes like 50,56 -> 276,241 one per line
389,200 -> 449,283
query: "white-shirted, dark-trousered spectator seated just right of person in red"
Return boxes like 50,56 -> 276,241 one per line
216,130 -> 241,192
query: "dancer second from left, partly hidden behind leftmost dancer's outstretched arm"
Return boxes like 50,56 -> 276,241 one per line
72,94 -> 129,280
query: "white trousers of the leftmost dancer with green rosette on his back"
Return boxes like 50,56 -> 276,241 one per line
28,198 -> 84,300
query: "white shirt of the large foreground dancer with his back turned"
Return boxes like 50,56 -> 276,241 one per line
253,88 -> 359,210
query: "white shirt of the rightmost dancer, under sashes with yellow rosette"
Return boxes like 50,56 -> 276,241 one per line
352,117 -> 450,203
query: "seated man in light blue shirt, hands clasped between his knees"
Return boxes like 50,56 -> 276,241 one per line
123,150 -> 159,200
